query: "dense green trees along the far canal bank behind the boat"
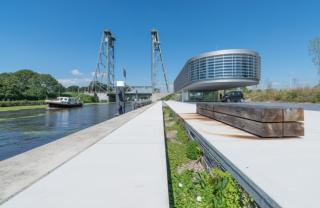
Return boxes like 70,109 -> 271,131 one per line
0,69 -> 107,103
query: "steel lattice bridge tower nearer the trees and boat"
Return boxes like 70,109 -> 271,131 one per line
90,30 -> 116,93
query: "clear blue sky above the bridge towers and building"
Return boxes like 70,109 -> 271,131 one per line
0,0 -> 320,87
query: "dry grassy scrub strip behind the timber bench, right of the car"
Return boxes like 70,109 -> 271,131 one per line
243,87 -> 320,103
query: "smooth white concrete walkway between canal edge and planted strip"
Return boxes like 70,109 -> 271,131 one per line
0,102 -> 169,208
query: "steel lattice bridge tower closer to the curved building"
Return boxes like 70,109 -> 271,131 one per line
151,29 -> 169,93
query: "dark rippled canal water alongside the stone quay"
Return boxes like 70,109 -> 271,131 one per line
0,103 -> 132,161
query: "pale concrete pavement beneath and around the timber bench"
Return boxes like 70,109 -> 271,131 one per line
166,101 -> 320,208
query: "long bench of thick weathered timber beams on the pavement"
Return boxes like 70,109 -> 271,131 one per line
197,103 -> 304,137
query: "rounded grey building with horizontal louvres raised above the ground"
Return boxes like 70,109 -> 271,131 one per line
174,49 -> 261,92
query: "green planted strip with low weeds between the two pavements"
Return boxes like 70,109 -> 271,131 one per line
164,108 -> 254,208
